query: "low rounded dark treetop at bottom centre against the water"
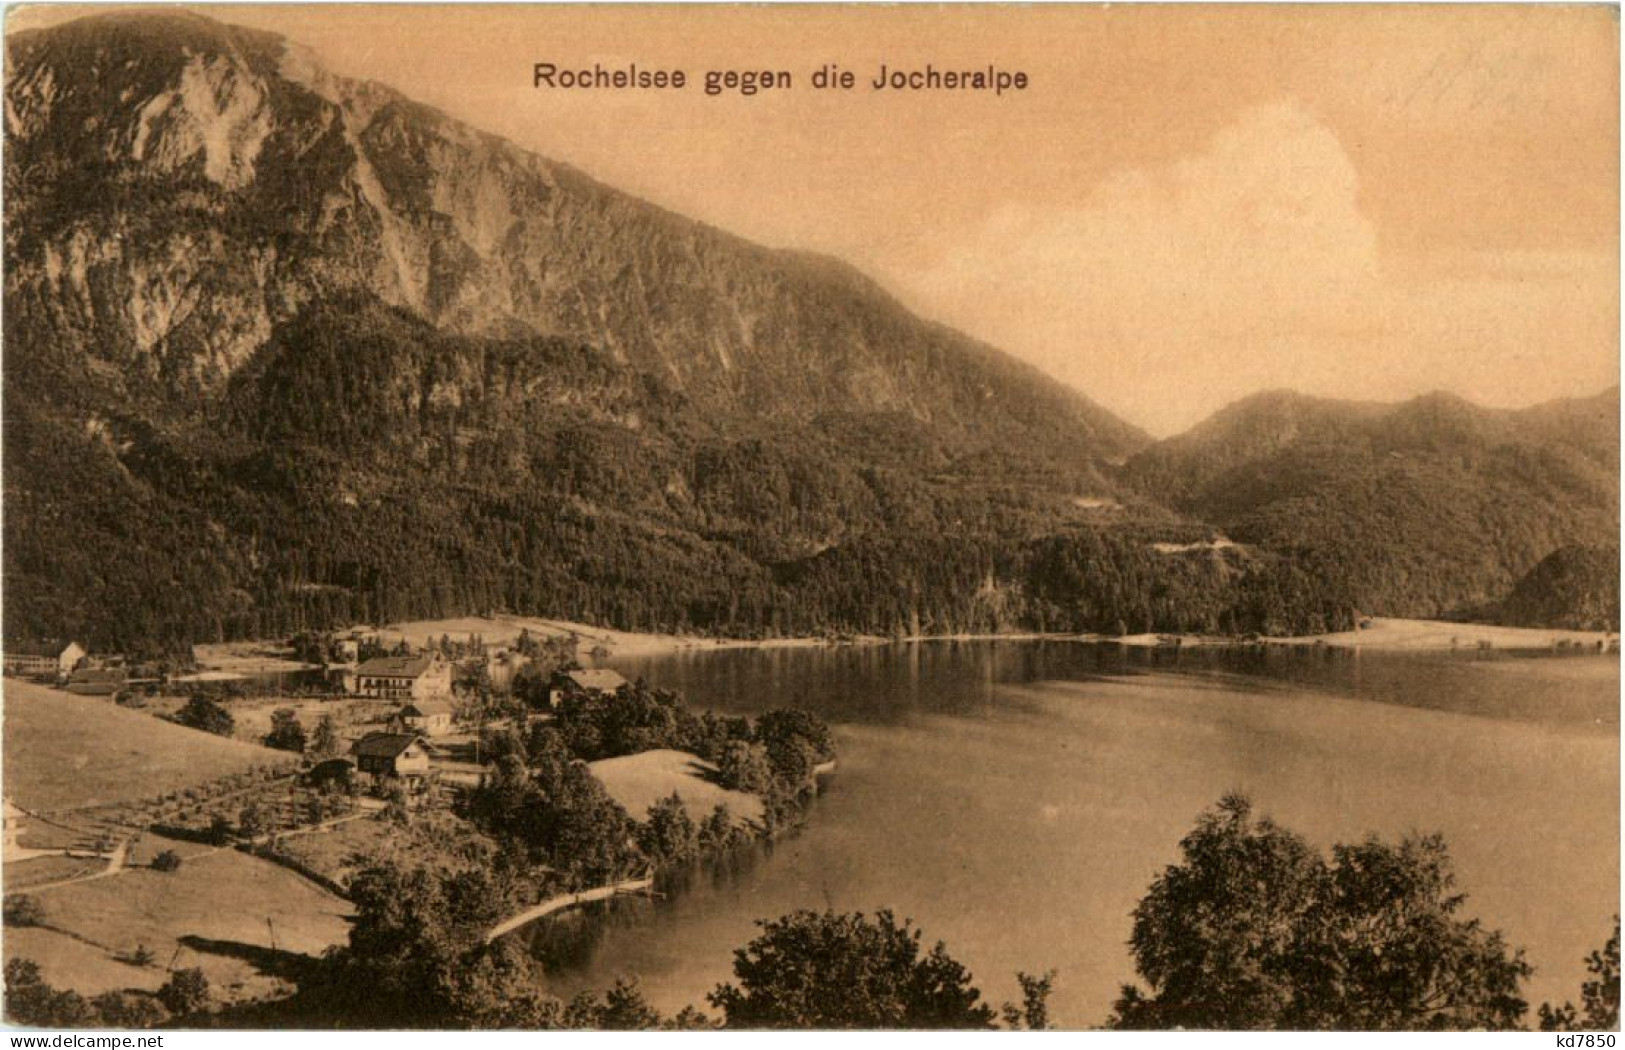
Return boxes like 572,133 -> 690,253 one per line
709,910 -> 993,1029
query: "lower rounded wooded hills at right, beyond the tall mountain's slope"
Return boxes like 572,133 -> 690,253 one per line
1126,388 -> 1620,616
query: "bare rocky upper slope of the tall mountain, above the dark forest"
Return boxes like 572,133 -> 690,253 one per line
5,13 -> 1144,458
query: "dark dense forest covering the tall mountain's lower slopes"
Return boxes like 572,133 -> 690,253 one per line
5,299 -> 1352,653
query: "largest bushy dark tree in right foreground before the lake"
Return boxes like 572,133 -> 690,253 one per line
1110,795 -> 1529,1030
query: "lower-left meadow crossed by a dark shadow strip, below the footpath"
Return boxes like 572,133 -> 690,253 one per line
17,850 -> 351,1000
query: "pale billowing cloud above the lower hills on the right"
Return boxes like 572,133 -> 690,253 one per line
902,101 -> 1617,432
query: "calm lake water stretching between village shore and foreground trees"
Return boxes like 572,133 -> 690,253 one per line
531,642 -> 1620,1027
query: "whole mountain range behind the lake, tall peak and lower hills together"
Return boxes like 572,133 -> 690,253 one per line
3,11 -> 1619,655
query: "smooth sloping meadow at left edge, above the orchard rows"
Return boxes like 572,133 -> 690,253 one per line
5,678 -> 294,813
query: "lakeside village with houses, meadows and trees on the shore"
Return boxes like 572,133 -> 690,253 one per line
3,627 -> 834,1009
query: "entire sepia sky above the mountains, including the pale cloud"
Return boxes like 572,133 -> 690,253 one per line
8,5 -> 1620,436
